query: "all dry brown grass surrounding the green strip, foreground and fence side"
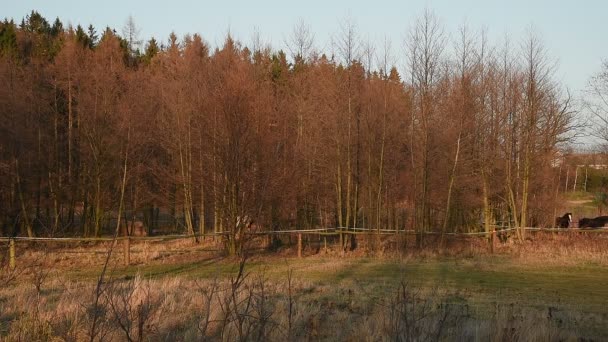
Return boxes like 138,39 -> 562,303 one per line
0,233 -> 608,341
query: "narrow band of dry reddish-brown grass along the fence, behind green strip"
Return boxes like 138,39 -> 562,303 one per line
8,232 -> 608,270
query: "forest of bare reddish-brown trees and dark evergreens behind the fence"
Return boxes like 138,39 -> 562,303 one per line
0,12 -> 575,247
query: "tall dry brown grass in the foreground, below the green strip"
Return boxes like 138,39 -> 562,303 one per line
0,275 -> 588,341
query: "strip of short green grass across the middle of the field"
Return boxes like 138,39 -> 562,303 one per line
67,256 -> 608,312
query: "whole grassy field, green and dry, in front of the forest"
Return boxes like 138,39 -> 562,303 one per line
0,232 -> 608,340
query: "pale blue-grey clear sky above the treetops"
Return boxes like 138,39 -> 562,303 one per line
0,0 -> 608,144
